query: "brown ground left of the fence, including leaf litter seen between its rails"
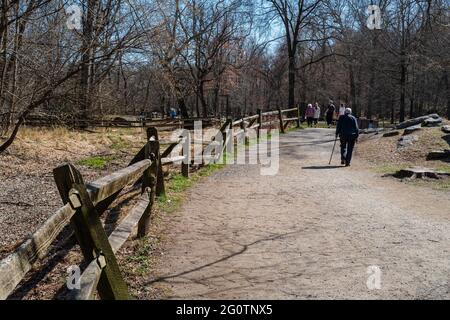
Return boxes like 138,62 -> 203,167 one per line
0,128 -> 152,299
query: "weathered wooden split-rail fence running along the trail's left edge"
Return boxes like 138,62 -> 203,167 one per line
0,108 -> 300,300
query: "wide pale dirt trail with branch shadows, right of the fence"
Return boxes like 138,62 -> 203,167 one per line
149,129 -> 450,299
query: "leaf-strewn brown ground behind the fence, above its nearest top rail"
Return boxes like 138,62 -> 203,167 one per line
0,128 -> 145,254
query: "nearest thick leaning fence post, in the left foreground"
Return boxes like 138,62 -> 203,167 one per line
53,164 -> 129,300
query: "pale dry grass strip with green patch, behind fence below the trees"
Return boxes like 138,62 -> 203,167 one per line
0,127 -> 150,176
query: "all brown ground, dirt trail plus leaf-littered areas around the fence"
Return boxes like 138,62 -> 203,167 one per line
0,125 -> 449,299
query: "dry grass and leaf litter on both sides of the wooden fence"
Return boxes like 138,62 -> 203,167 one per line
0,124 -> 224,299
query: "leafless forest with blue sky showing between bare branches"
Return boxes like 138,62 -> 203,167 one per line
0,0 -> 450,152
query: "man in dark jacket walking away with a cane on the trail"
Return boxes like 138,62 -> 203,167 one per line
336,108 -> 359,167
